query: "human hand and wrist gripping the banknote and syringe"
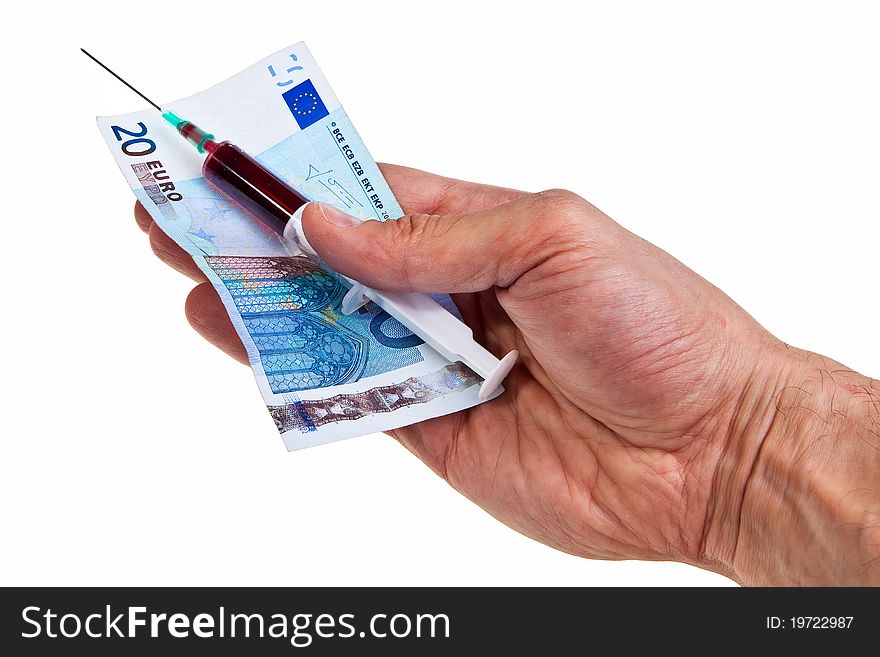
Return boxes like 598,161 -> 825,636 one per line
139,166 -> 880,583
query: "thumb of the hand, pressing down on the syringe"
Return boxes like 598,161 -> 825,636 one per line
302,190 -> 587,292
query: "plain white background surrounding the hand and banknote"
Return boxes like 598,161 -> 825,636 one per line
0,0 -> 880,585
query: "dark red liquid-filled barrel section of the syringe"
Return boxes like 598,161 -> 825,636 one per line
202,141 -> 308,235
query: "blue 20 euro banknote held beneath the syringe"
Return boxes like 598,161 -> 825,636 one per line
98,43 -> 481,450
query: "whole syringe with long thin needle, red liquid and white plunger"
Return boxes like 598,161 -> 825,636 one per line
83,50 -> 518,401
